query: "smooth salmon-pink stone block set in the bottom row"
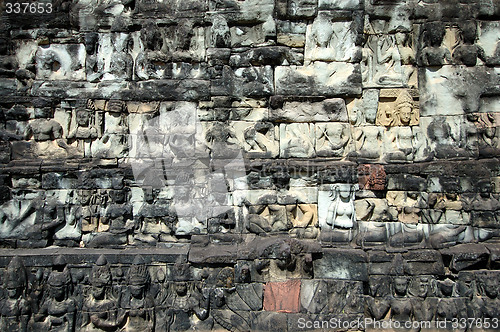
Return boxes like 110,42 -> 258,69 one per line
264,280 -> 300,313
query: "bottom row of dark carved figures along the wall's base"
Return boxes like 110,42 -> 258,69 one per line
0,255 -> 500,331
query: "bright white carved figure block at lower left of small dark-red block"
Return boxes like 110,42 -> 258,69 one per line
318,184 -> 359,230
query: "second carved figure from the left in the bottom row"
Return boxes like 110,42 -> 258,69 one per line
35,257 -> 76,332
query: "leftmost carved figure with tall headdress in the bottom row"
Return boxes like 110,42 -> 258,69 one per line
0,256 -> 31,332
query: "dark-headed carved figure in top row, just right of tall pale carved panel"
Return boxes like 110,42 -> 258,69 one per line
421,22 -> 452,66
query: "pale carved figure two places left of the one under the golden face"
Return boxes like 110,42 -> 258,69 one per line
316,123 -> 351,157
